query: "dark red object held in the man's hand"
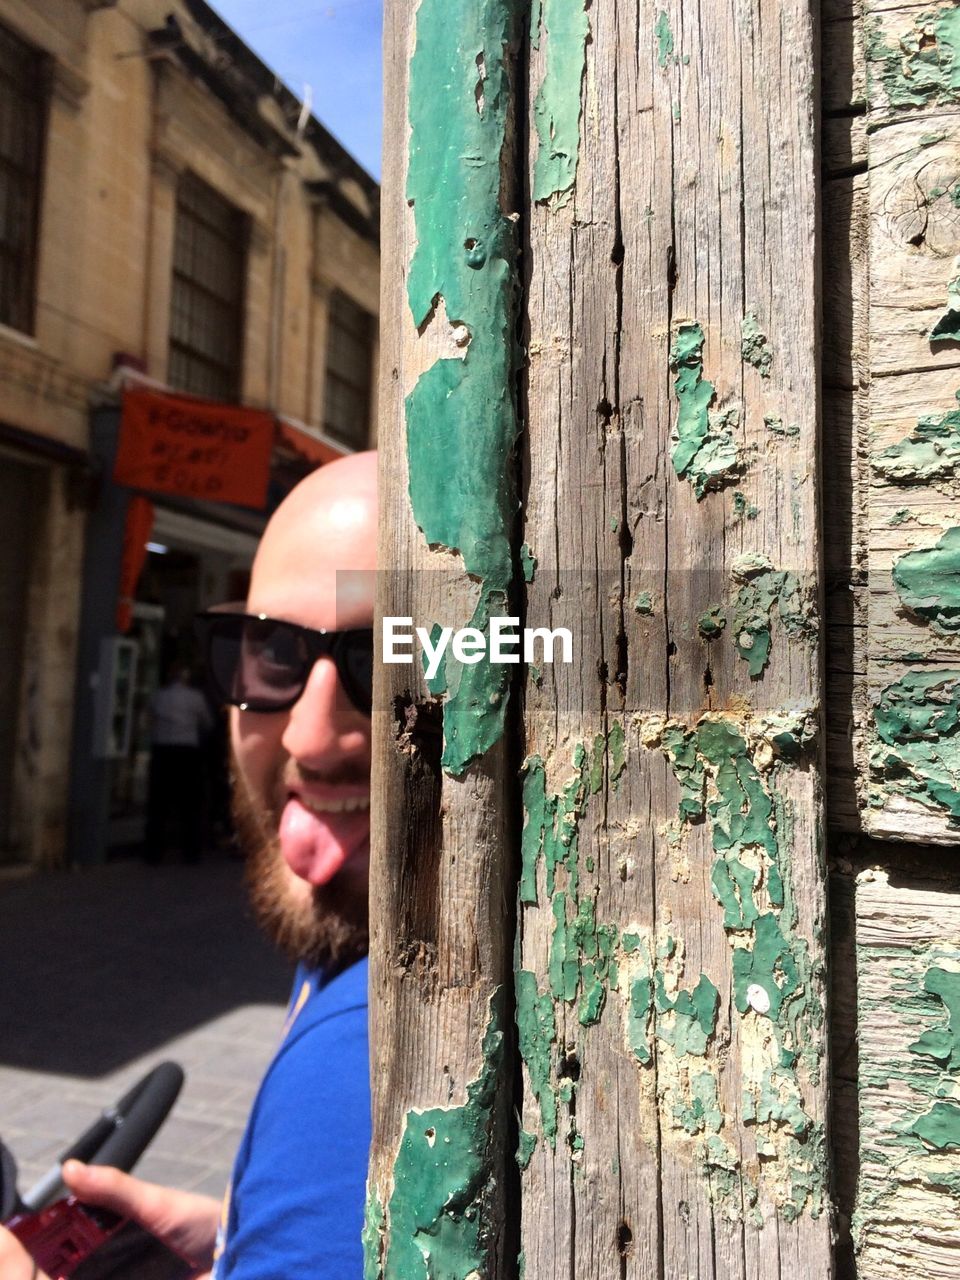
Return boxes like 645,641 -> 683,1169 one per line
5,1196 -> 196,1280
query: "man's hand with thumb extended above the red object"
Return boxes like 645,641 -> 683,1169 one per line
61,1160 -> 220,1280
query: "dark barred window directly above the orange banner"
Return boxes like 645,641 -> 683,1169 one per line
166,174 -> 247,401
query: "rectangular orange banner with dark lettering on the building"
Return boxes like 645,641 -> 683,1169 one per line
114,390 -> 276,511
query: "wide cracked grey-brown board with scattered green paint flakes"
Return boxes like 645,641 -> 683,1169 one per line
518,0 -> 832,1280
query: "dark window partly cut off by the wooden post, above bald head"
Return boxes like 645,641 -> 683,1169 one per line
324,293 -> 375,449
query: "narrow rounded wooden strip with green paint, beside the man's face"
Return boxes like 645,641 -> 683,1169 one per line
365,0 -> 517,1277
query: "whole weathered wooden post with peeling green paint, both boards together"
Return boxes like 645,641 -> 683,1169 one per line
366,0 -> 832,1280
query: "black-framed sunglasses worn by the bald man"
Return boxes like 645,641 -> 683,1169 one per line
196,609 -> 374,716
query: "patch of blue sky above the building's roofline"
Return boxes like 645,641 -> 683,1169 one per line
209,0 -> 383,178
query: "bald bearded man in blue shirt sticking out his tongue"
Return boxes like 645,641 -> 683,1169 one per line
0,453 -> 376,1280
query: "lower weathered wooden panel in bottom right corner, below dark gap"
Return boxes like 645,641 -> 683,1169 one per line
854,870 -> 960,1280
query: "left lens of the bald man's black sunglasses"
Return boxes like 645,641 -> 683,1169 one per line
207,617 -> 310,710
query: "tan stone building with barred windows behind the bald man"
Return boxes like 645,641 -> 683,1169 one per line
0,0 -> 379,867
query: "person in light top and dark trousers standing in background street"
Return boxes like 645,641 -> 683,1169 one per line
145,666 -> 214,865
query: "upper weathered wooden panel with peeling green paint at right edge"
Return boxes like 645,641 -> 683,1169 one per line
855,0 -> 960,844
